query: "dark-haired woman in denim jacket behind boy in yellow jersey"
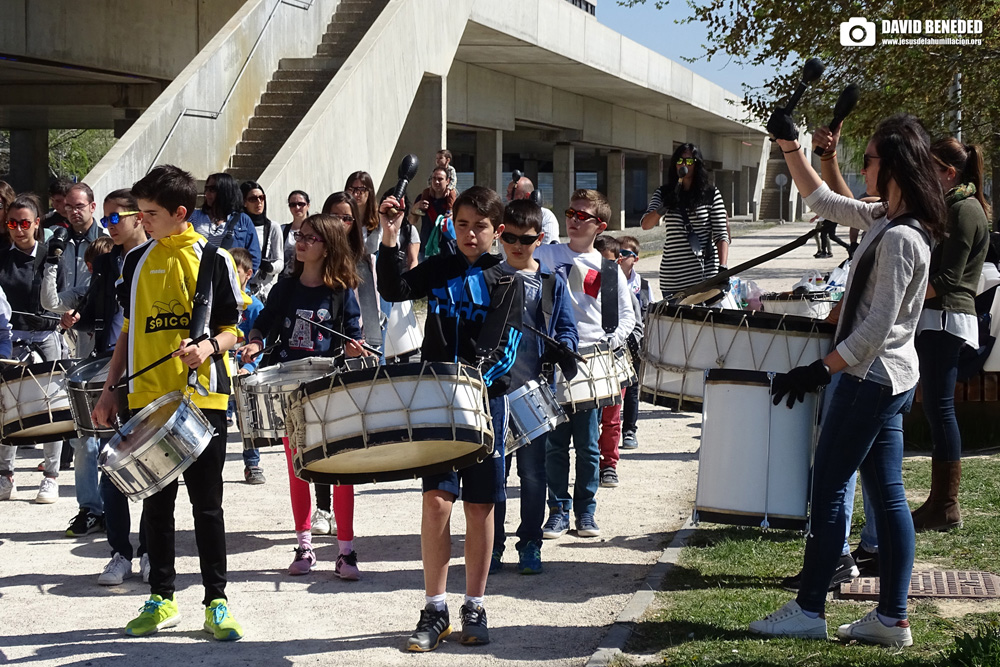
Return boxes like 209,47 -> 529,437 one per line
188,173 -> 260,272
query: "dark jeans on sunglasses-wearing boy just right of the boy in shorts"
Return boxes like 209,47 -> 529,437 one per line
493,434 -> 548,553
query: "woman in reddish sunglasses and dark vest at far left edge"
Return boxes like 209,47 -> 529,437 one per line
0,194 -> 62,504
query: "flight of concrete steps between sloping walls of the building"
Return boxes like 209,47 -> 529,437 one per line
226,0 -> 388,182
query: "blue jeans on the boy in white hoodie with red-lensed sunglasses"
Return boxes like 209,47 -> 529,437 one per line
545,410 -> 601,516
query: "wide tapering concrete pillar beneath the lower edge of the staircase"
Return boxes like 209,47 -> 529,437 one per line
382,74 -> 448,200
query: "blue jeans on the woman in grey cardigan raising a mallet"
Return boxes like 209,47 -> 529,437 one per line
796,375 -> 914,619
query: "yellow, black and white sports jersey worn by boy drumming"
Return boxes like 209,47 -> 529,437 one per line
117,225 -> 250,410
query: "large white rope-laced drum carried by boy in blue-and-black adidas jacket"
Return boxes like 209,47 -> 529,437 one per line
288,362 -> 493,484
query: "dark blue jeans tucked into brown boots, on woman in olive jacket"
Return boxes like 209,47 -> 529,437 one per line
916,331 -> 965,461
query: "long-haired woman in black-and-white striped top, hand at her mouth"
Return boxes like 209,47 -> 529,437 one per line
642,144 -> 729,296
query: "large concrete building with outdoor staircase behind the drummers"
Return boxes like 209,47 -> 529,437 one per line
0,0 -> 770,229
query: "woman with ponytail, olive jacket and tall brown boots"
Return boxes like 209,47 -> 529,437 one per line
913,137 -> 990,533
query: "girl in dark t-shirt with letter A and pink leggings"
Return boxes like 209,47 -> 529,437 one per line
242,215 -> 367,580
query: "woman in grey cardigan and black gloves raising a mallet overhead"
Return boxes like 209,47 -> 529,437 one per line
750,109 -> 945,647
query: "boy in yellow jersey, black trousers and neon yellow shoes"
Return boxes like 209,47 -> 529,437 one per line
94,165 -> 248,640
